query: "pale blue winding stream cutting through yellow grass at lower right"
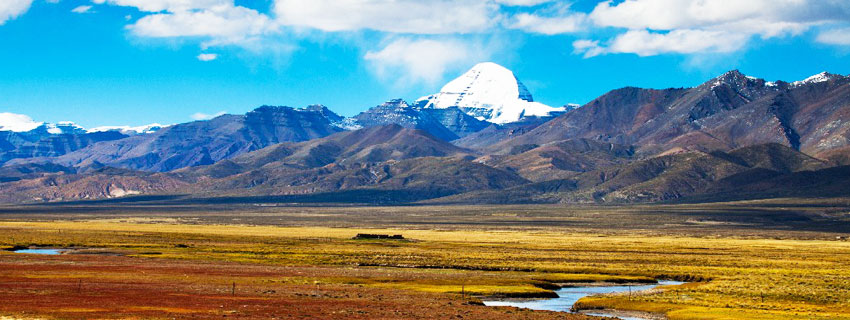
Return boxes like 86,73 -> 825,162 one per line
484,281 -> 684,320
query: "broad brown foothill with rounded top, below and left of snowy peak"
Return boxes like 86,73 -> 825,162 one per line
166,124 -> 527,199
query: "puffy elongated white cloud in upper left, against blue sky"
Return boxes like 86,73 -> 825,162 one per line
128,5 -> 275,47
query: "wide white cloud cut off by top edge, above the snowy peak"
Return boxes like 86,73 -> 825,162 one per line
274,0 -> 499,34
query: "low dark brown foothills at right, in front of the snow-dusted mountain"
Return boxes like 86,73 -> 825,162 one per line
433,143 -> 828,203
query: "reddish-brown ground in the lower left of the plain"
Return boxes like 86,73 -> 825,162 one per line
0,253 -> 592,319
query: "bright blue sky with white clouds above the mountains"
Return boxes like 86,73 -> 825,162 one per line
0,0 -> 850,127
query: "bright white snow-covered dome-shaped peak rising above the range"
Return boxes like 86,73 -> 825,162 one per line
414,62 -> 566,124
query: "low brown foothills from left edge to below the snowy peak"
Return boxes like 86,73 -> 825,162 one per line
0,125 -> 528,202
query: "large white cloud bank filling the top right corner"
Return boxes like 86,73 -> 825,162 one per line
573,0 -> 850,57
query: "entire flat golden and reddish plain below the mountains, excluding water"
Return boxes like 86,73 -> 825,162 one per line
0,199 -> 850,319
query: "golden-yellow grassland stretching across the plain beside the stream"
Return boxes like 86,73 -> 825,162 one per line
0,219 -> 850,319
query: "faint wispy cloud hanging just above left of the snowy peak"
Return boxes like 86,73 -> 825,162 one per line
365,38 -> 489,84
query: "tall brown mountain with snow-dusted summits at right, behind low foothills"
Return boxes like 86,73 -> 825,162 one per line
498,71 -> 850,162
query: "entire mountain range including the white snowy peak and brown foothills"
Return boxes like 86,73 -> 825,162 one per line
0,63 -> 850,203
